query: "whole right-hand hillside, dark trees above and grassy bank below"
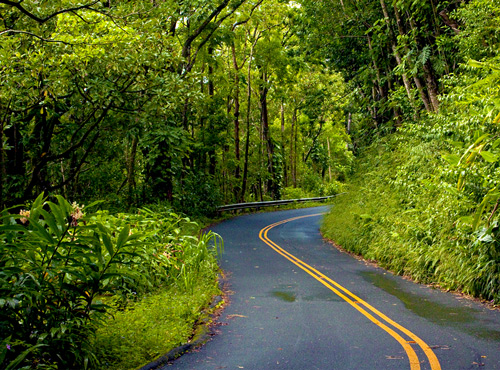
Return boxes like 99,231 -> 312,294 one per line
316,0 -> 500,312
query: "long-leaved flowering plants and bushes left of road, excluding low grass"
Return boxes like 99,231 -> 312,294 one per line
0,195 -> 222,369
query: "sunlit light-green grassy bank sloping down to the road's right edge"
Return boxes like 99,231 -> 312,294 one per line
322,120 -> 500,302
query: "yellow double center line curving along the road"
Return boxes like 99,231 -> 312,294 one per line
259,213 -> 441,370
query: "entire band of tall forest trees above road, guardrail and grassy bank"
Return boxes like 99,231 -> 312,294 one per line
0,0 -> 498,212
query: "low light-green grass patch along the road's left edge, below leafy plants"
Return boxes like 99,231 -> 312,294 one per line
95,277 -> 220,370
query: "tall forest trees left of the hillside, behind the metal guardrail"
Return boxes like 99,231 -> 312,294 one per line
0,0 -> 352,214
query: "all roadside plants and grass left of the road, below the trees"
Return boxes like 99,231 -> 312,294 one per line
0,196 -> 222,369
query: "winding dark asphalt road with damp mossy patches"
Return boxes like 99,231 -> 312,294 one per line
162,207 -> 500,370
